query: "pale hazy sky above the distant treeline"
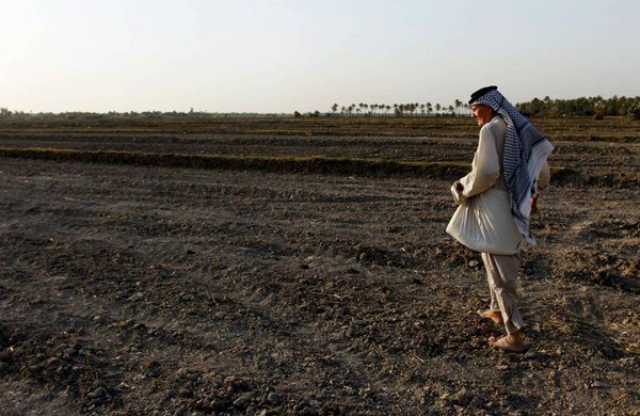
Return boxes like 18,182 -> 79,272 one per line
0,0 -> 640,112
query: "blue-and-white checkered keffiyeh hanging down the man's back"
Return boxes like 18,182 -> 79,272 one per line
472,90 -> 553,244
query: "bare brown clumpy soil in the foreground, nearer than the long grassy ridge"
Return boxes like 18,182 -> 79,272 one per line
0,134 -> 640,416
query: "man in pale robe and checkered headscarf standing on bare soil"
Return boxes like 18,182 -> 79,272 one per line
447,86 -> 553,352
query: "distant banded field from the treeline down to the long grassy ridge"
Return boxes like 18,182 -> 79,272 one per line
0,117 -> 640,185
